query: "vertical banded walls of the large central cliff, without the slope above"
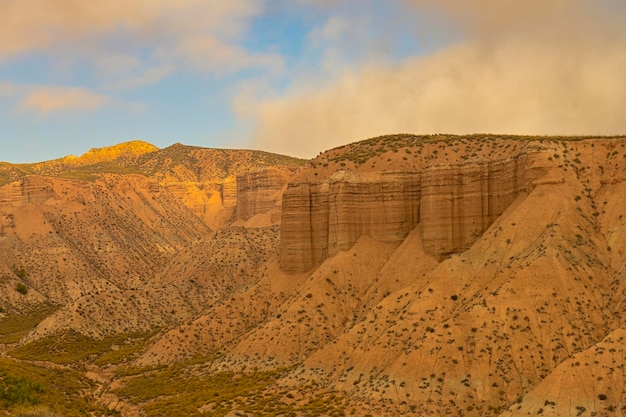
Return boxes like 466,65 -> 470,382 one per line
280,155 -> 527,272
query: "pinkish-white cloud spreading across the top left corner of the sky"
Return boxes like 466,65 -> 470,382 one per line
0,0 -> 272,87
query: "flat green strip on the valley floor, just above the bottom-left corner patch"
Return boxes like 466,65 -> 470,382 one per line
9,330 -> 156,365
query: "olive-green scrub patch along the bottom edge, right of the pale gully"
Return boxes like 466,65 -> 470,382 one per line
115,365 -> 344,416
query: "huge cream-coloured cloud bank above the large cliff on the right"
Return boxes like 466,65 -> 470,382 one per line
246,0 -> 626,157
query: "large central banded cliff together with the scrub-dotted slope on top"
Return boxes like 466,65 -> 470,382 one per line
280,136 -> 556,272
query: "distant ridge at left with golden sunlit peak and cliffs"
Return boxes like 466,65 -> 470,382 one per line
0,141 -> 305,230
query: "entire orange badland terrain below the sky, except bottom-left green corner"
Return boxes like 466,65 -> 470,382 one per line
0,135 -> 626,417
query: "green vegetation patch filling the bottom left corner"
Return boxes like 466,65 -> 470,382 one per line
0,358 -> 118,417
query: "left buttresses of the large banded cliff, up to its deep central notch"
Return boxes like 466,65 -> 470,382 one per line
281,170 -> 421,272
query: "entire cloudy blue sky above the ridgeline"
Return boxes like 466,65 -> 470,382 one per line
0,0 -> 626,162
